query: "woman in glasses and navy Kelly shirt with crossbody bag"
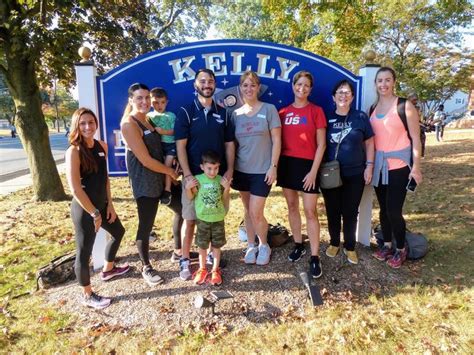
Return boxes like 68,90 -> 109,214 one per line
321,80 -> 374,264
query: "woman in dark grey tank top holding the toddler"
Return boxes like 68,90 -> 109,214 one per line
120,83 -> 178,286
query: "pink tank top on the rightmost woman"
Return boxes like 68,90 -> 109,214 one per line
370,100 -> 410,170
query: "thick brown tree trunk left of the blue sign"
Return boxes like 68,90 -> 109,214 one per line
7,56 -> 66,201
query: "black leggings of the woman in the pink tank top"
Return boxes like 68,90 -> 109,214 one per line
375,166 -> 410,249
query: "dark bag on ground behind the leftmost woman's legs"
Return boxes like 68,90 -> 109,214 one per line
36,252 -> 76,290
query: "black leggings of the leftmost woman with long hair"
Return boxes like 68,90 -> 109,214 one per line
71,200 -> 125,286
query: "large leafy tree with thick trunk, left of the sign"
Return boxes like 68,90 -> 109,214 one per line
0,0 -> 210,200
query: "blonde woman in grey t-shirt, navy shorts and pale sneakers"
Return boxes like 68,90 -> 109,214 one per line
232,71 -> 281,265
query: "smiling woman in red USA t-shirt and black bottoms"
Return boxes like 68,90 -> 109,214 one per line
277,71 -> 326,278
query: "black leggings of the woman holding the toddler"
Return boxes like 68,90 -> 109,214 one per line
136,196 -> 160,266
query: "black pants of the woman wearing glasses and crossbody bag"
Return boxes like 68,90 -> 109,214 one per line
321,174 -> 365,251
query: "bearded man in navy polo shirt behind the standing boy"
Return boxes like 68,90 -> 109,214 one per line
174,69 -> 235,280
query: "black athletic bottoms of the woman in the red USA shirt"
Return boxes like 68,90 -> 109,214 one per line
277,155 -> 320,194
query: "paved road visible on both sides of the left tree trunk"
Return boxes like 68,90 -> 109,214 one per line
0,133 -> 69,182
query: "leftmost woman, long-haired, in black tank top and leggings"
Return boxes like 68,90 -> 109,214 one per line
66,108 -> 130,309
